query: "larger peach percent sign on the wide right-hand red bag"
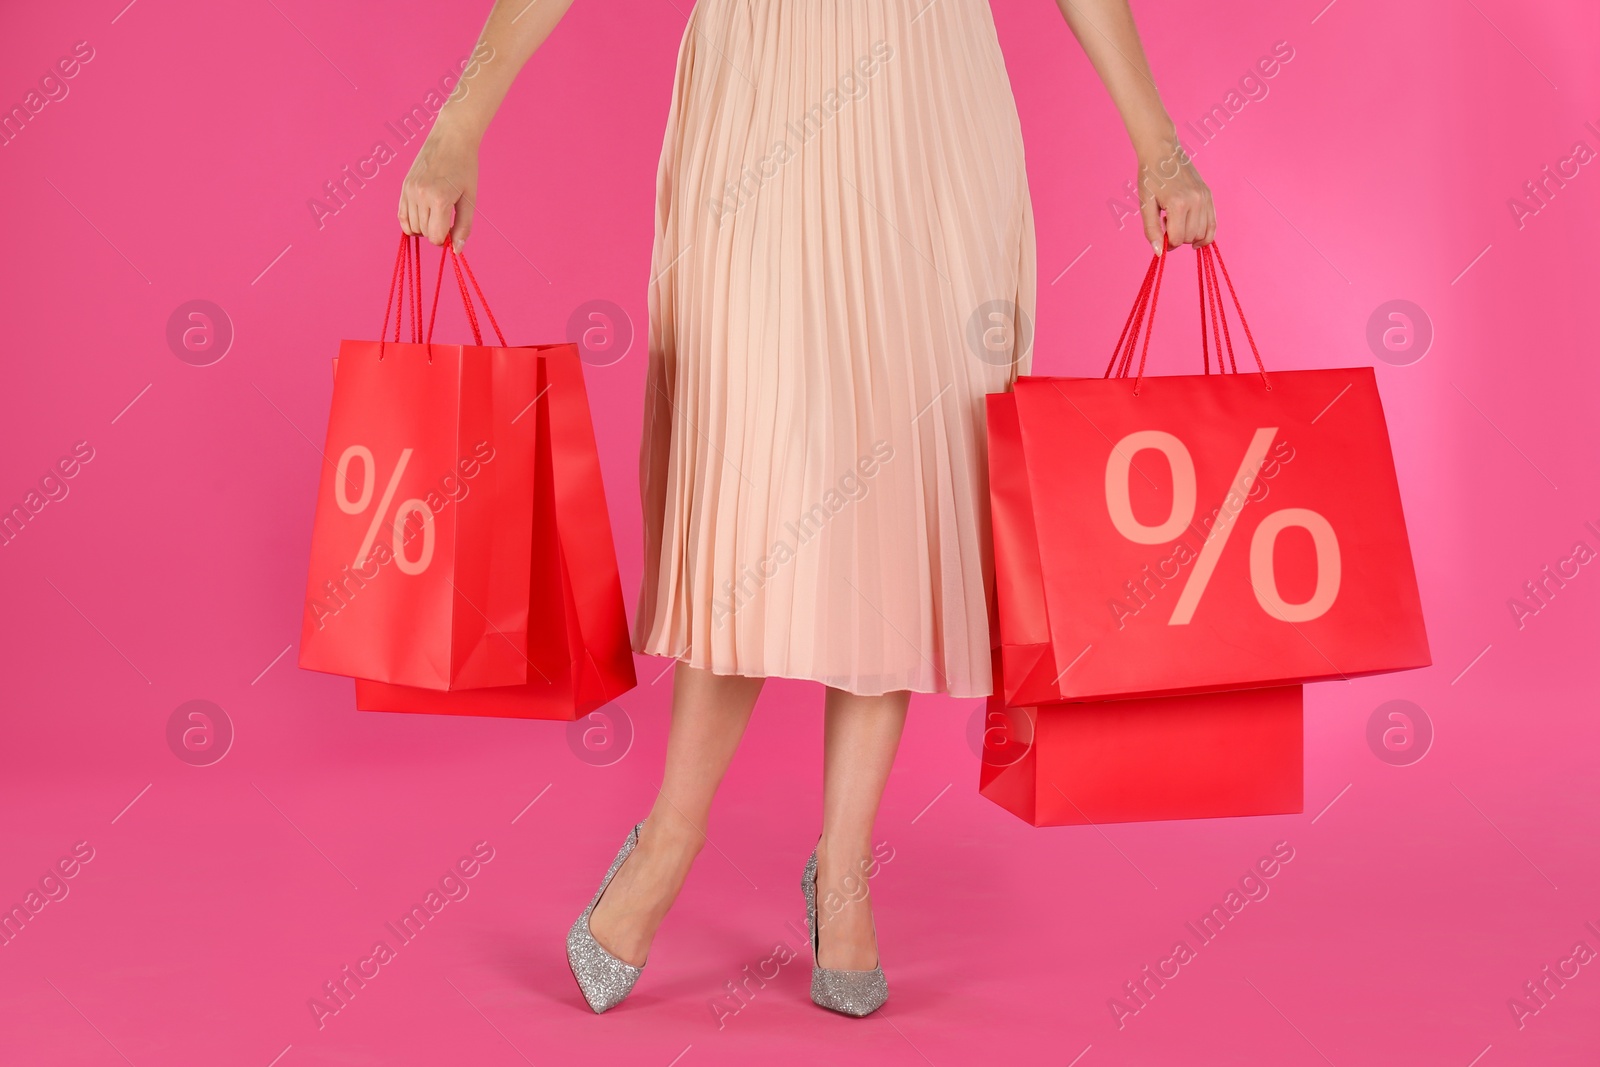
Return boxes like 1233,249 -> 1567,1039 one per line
1106,426 -> 1341,625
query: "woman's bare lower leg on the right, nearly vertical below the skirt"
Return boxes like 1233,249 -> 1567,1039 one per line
816,688 -> 910,971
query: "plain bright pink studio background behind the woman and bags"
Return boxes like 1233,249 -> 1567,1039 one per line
0,0 -> 1600,1067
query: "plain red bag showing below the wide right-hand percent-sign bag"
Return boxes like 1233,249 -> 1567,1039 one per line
978,652 -> 1304,825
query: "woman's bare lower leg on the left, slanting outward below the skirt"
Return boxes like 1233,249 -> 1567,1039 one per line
589,664 -> 763,966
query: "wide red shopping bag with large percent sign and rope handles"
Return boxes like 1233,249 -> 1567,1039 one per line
987,246 -> 1430,707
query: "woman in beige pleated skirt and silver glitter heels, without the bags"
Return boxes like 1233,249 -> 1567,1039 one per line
400,0 -> 1216,1016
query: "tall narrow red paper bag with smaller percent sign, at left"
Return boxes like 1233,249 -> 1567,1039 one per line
299,238 -> 538,689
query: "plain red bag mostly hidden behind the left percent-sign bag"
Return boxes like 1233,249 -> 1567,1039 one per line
355,329 -> 635,720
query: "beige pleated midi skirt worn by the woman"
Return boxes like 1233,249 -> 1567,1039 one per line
634,0 -> 1037,696
